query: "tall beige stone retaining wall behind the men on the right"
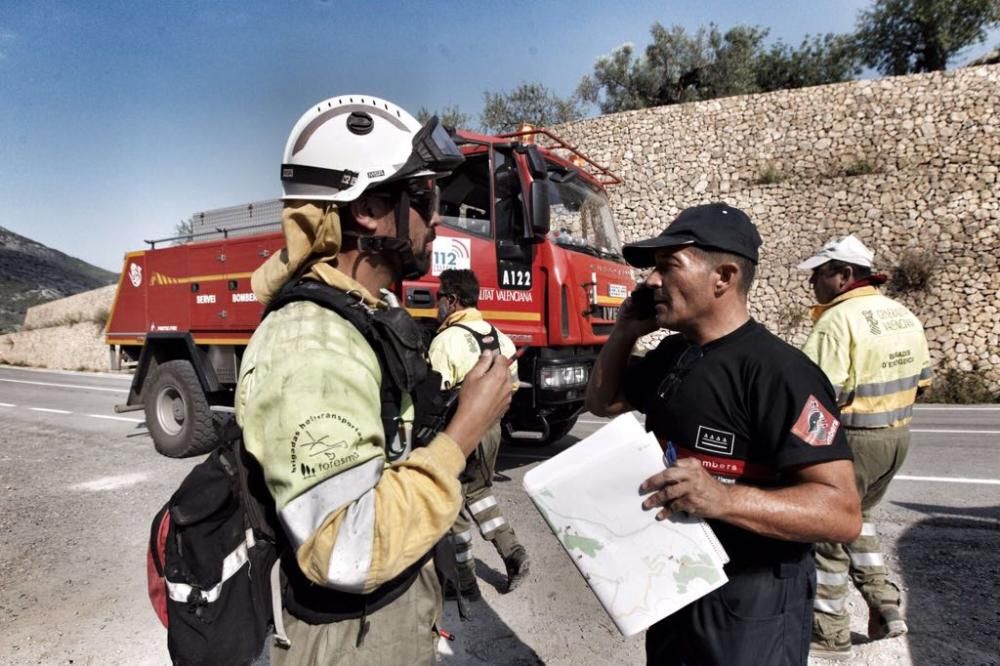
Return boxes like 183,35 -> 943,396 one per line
557,65 -> 1000,390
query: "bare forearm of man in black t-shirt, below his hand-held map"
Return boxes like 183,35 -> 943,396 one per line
716,482 -> 861,543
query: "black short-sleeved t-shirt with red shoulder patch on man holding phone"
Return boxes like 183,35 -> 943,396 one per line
625,319 -> 851,566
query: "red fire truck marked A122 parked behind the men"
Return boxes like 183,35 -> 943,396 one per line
106,129 -> 634,457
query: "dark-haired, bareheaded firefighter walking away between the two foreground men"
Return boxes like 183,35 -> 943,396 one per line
429,270 -> 529,600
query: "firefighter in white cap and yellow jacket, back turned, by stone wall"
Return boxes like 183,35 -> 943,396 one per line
799,235 -> 931,659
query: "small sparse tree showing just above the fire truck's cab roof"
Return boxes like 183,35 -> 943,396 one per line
479,83 -> 583,133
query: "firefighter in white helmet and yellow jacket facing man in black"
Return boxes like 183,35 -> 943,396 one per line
236,96 -> 510,664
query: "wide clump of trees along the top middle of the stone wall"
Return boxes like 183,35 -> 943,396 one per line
577,23 -> 857,113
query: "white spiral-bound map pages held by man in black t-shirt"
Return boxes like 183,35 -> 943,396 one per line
524,414 -> 729,636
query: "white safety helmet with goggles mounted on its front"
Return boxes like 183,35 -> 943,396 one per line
281,95 -> 463,202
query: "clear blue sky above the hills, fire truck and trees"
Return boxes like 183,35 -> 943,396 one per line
0,0 -> 1000,271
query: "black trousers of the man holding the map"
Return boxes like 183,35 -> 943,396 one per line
646,556 -> 816,666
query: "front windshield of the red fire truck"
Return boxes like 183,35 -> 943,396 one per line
548,164 -> 623,261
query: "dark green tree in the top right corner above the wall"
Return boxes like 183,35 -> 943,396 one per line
855,0 -> 1000,75
